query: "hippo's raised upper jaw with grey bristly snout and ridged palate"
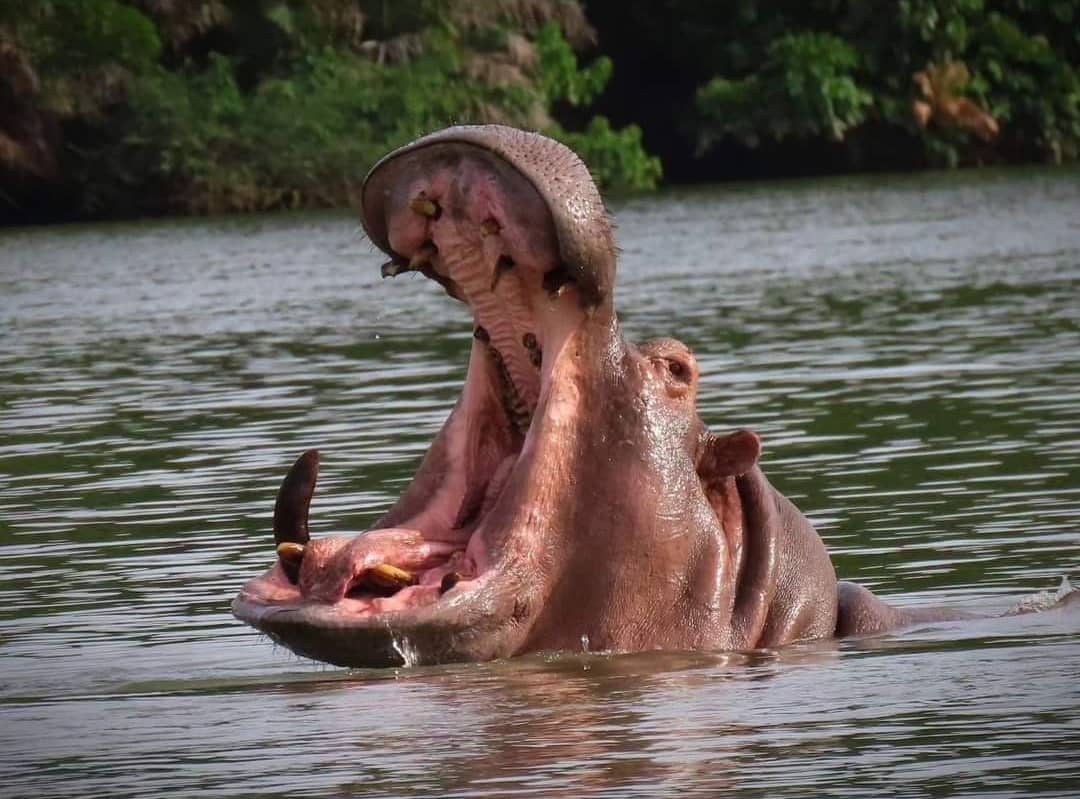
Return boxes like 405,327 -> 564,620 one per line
361,125 -> 615,449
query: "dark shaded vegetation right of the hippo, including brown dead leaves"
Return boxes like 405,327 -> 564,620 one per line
589,0 -> 1080,180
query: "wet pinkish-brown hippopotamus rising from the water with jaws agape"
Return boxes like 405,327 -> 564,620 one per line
232,125 -> 955,666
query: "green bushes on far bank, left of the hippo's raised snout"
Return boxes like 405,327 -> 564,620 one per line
129,36 -> 475,211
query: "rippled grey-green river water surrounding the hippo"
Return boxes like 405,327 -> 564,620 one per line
0,171 -> 1080,797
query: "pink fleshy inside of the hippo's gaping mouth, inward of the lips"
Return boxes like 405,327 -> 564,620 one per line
245,150 -> 585,622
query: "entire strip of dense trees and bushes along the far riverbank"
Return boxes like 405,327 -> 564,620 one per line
0,0 -> 1080,220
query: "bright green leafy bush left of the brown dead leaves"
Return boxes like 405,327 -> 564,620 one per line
697,33 -> 872,150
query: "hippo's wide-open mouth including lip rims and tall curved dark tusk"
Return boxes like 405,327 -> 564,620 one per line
233,129 -> 602,664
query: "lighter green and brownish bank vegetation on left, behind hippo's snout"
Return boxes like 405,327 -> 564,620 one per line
0,0 -> 660,220
